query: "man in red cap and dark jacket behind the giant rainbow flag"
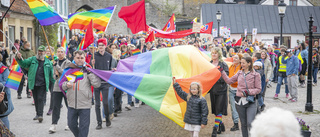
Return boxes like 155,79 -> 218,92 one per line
91,38 -> 114,130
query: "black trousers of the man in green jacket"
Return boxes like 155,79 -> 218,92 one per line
32,85 -> 46,116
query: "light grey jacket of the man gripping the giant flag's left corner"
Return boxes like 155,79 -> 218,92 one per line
62,69 -> 101,109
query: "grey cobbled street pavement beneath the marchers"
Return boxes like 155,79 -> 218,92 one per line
9,79 -> 320,137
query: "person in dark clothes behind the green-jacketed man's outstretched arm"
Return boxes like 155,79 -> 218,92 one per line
17,41 -> 35,99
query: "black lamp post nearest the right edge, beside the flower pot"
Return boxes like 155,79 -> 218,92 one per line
305,15 -> 313,112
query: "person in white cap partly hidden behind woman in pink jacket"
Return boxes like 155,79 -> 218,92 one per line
253,61 -> 266,112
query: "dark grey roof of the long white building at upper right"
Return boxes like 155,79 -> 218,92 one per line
201,4 -> 320,34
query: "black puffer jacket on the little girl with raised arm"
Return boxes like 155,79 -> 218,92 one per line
173,83 -> 208,125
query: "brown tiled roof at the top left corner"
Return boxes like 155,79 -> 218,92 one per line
10,0 -> 33,15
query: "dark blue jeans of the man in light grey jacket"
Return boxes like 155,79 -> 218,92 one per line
68,107 -> 90,137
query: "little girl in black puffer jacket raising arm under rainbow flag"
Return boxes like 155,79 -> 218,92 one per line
172,77 -> 208,137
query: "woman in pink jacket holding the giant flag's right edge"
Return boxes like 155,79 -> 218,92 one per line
219,57 -> 261,137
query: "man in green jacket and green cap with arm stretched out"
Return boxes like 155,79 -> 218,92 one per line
17,45 -> 55,123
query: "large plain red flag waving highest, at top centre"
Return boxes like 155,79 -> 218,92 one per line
118,0 -> 147,34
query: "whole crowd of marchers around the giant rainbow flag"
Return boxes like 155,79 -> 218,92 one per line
0,34 -> 320,137
